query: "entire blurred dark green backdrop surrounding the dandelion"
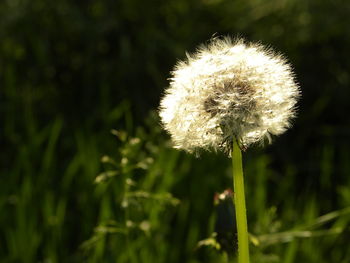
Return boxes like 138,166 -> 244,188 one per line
0,0 -> 350,263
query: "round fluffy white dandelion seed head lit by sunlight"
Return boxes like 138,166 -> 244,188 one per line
160,38 -> 300,155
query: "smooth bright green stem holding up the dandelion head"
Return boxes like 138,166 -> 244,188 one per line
232,140 -> 249,263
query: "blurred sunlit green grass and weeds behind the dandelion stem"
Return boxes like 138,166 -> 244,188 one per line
0,103 -> 350,263
